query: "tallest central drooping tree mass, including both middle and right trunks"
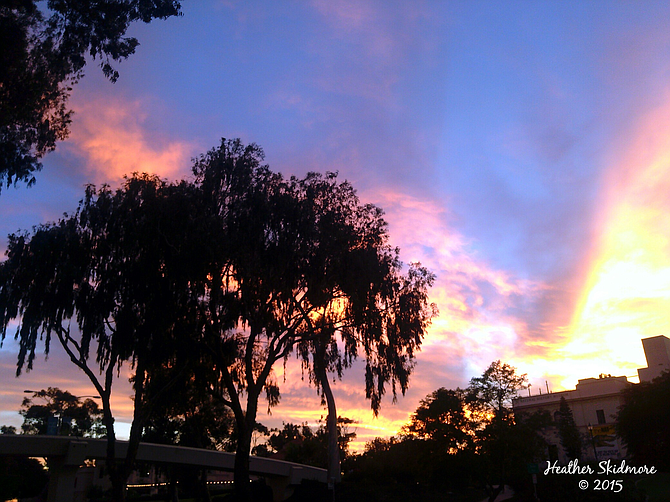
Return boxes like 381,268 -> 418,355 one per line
194,140 -> 433,499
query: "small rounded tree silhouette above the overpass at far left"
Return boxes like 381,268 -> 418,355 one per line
19,387 -> 102,437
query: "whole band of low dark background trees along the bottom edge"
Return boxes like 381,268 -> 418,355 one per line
0,361 -> 670,501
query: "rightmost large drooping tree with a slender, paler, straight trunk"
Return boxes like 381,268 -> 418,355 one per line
292,173 -> 437,490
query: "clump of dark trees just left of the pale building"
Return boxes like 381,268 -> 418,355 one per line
345,361 -> 549,500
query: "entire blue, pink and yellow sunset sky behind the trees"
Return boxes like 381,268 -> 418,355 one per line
0,0 -> 670,448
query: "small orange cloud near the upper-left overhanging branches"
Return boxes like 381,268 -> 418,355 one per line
67,98 -> 197,183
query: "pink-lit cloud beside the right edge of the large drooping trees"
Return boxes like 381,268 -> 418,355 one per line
346,189 -> 550,406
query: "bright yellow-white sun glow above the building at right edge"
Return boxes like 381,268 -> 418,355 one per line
561,97 -> 670,387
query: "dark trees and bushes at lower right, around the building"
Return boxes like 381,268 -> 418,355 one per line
342,361 -> 670,502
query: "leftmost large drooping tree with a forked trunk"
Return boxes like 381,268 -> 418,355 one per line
0,175 -> 201,501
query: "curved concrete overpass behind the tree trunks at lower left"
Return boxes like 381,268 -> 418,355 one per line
0,434 -> 327,502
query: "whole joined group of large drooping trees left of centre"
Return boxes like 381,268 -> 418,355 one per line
0,140 -> 436,497
